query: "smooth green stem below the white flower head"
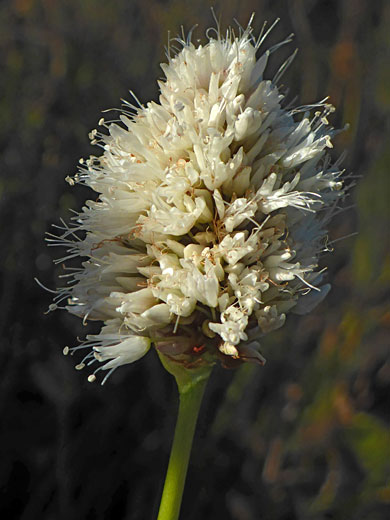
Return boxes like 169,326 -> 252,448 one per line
157,370 -> 211,520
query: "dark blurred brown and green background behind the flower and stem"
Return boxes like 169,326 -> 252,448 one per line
0,0 -> 390,520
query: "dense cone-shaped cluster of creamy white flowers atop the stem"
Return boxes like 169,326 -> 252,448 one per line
49,19 -> 343,380
